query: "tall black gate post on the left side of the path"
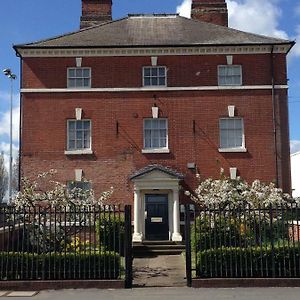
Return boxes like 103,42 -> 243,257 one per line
124,205 -> 133,289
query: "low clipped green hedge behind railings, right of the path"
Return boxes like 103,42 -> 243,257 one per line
196,244 -> 300,278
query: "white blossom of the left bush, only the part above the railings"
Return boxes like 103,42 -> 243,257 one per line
12,170 -> 113,209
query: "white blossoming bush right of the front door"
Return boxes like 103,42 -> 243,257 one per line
186,174 -> 295,251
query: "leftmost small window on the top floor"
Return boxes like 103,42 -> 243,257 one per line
68,68 -> 91,89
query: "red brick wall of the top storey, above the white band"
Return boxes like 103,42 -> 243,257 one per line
22,54 -> 287,88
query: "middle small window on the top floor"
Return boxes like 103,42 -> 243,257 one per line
143,67 -> 167,87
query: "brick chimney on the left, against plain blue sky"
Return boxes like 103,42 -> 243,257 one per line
80,0 -> 112,29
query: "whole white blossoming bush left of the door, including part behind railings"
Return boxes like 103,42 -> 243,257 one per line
11,170 -> 113,253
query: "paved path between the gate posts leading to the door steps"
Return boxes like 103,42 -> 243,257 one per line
133,255 -> 186,287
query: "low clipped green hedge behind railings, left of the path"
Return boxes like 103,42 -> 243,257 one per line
0,252 -> 121,280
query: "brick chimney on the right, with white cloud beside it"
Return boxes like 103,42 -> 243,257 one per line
192,0 -> 228,27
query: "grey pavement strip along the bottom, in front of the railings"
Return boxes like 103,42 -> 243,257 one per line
0,287 -> 300,300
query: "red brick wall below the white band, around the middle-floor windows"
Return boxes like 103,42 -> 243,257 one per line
22,90 -> 289,203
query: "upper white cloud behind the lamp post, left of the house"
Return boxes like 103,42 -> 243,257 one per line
0,107 -> 20,142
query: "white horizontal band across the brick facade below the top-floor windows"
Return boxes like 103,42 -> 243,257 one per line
21,85 -> 289,93
